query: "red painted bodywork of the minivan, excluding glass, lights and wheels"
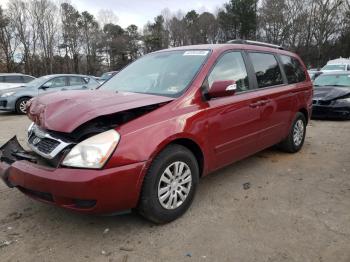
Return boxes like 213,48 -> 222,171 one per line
0,44 -> 313,213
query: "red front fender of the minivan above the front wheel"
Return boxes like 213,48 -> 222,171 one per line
106,110 -> 208,168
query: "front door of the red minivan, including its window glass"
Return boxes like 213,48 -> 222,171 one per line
208,51 -> 261,169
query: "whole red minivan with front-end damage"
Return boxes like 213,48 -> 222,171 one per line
0,41 -> 313,223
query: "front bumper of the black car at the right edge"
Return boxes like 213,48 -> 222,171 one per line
312,105 -> 350,119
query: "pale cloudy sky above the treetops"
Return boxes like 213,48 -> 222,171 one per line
0,0 -> 228,28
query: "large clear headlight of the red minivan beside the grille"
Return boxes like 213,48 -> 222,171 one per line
62,130 -> 120,168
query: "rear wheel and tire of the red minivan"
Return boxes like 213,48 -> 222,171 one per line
278,112 -> 306,153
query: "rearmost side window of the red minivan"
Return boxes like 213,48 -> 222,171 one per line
280,55 -> 306,84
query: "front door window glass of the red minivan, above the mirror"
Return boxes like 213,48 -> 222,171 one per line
208,52 -> 249,92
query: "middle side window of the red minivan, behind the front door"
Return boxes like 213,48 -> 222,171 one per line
249,53 -> 283,88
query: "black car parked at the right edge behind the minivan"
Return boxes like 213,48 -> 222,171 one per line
312,72 -> 350,119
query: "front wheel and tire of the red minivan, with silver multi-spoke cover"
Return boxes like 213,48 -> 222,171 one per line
138,145 -> 199,224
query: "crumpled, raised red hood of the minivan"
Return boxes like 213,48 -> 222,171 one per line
27,90 -> 174,133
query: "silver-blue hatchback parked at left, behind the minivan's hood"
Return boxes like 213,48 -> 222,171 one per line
0,74 -> 100,114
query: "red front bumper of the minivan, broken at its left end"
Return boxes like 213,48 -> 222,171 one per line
0,136 -> 146,214
